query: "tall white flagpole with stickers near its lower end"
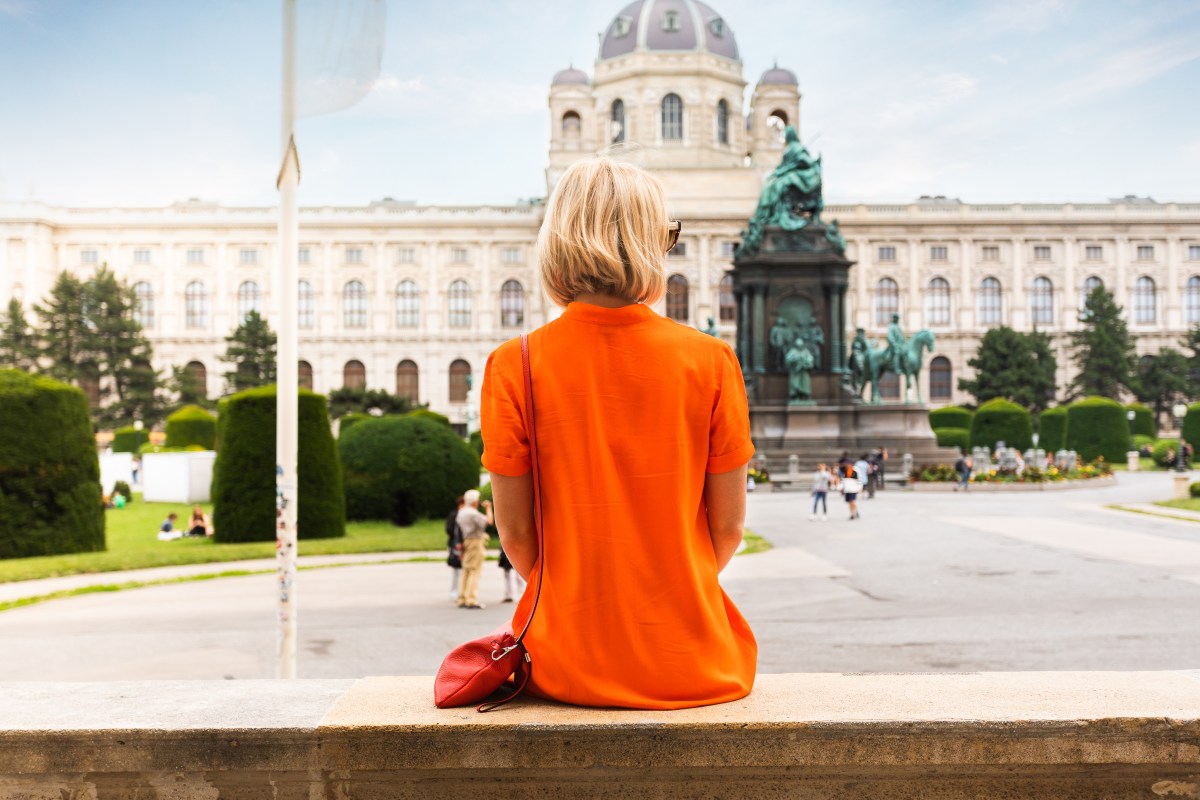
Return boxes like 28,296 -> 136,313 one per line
275,0 -> 300,678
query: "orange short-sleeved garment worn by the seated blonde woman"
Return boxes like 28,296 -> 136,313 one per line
480,302 -> 758,709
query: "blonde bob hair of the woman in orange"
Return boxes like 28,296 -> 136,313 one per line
538,156 -> 670,306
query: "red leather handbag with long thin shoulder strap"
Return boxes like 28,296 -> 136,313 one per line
433,336 -> 546,711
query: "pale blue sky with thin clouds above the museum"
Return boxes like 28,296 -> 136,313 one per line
0,0 -> 1200,206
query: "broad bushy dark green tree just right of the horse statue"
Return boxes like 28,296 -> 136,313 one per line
959,325 -> 1058,414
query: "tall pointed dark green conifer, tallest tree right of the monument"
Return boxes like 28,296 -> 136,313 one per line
1070,287 -> 1136,399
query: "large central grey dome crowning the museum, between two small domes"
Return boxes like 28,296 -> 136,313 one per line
600,0 -> 738,61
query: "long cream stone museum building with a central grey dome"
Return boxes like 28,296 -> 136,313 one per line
0,0 -> 1200,427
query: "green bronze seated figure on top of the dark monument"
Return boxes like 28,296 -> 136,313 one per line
738,125 -> 846,257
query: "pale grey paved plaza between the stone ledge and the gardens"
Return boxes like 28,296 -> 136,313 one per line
0,473 -> 1200,680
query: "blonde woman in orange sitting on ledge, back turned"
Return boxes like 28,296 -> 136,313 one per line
481,157 -> 757,709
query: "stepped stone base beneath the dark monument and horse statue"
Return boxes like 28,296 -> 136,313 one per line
750,403 -> 959,474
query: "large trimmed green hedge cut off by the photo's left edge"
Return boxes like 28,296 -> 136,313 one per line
0,369 -> 104,558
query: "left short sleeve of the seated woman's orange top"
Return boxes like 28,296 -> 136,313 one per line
479,344 -> 529,477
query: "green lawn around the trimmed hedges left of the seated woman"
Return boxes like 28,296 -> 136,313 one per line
0,495 -> 446,583
